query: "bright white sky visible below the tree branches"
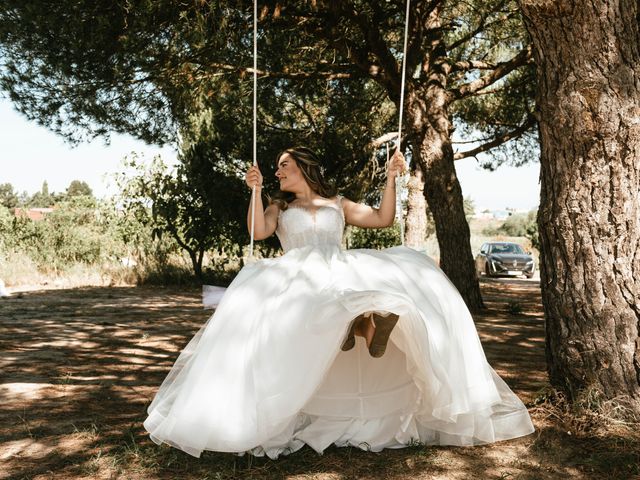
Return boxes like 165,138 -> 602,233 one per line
0,97 -> 540,211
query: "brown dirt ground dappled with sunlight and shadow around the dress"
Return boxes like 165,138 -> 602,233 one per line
0,279 -> 640,480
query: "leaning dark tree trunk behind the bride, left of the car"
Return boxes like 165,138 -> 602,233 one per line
407,85 -> 484,311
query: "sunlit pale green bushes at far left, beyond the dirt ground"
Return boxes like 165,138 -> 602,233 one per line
0,181 -> 208,284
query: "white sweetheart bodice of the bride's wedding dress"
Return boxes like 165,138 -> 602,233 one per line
276,196 -> 345,252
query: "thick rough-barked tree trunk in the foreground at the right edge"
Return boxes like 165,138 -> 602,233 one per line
520,0 -> 640,411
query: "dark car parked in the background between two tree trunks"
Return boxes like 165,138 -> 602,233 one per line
476,242 -> 536,278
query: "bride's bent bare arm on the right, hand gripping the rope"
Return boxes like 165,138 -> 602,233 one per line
342,151 -> 405,228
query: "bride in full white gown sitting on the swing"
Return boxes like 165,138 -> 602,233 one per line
144,148 -> 534,458
